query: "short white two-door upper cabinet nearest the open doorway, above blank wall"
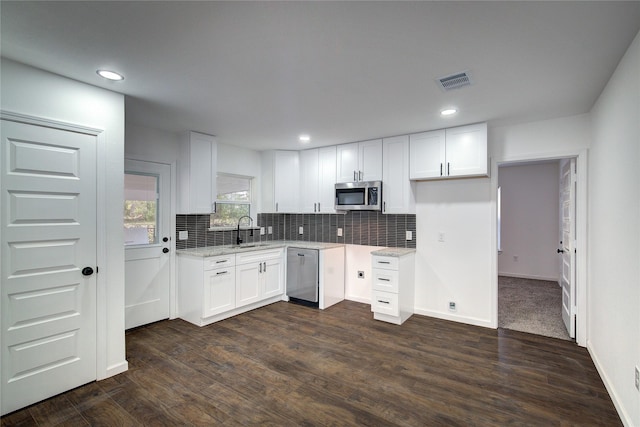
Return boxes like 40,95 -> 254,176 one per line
409,123 -> 489,180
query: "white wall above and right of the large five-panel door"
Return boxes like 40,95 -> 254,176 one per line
1,58 -> 127,379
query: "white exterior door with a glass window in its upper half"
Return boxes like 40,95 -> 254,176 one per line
124,160 -> 171,329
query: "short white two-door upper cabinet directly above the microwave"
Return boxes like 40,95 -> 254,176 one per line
336,139 -> 382,182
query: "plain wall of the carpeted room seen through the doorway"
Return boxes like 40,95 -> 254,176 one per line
498,161 -> 560,281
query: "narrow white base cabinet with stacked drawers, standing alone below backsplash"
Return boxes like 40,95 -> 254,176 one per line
371,250 -> 415,325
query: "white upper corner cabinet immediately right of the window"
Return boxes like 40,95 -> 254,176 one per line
262,151 -> 300,213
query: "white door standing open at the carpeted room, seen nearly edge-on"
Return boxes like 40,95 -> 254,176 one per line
558,159 -> 576,338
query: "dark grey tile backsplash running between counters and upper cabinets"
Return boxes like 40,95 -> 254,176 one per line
175,211 -> 417,249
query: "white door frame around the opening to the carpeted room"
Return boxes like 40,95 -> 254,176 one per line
491,149 -> 589,347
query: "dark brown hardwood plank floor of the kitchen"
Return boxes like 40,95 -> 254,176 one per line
2,301 -> 622,426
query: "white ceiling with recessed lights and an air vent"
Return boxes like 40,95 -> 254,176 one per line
0,1 -> 640,150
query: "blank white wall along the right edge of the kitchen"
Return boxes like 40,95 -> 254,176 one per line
587,30 -> 640,426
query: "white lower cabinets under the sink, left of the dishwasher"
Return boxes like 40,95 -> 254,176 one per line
178,248 -> 284,326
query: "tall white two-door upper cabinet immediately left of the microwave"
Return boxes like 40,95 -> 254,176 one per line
300,146 -> 336,213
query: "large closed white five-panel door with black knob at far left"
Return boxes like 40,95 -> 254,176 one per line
0,120 -> 97,414
